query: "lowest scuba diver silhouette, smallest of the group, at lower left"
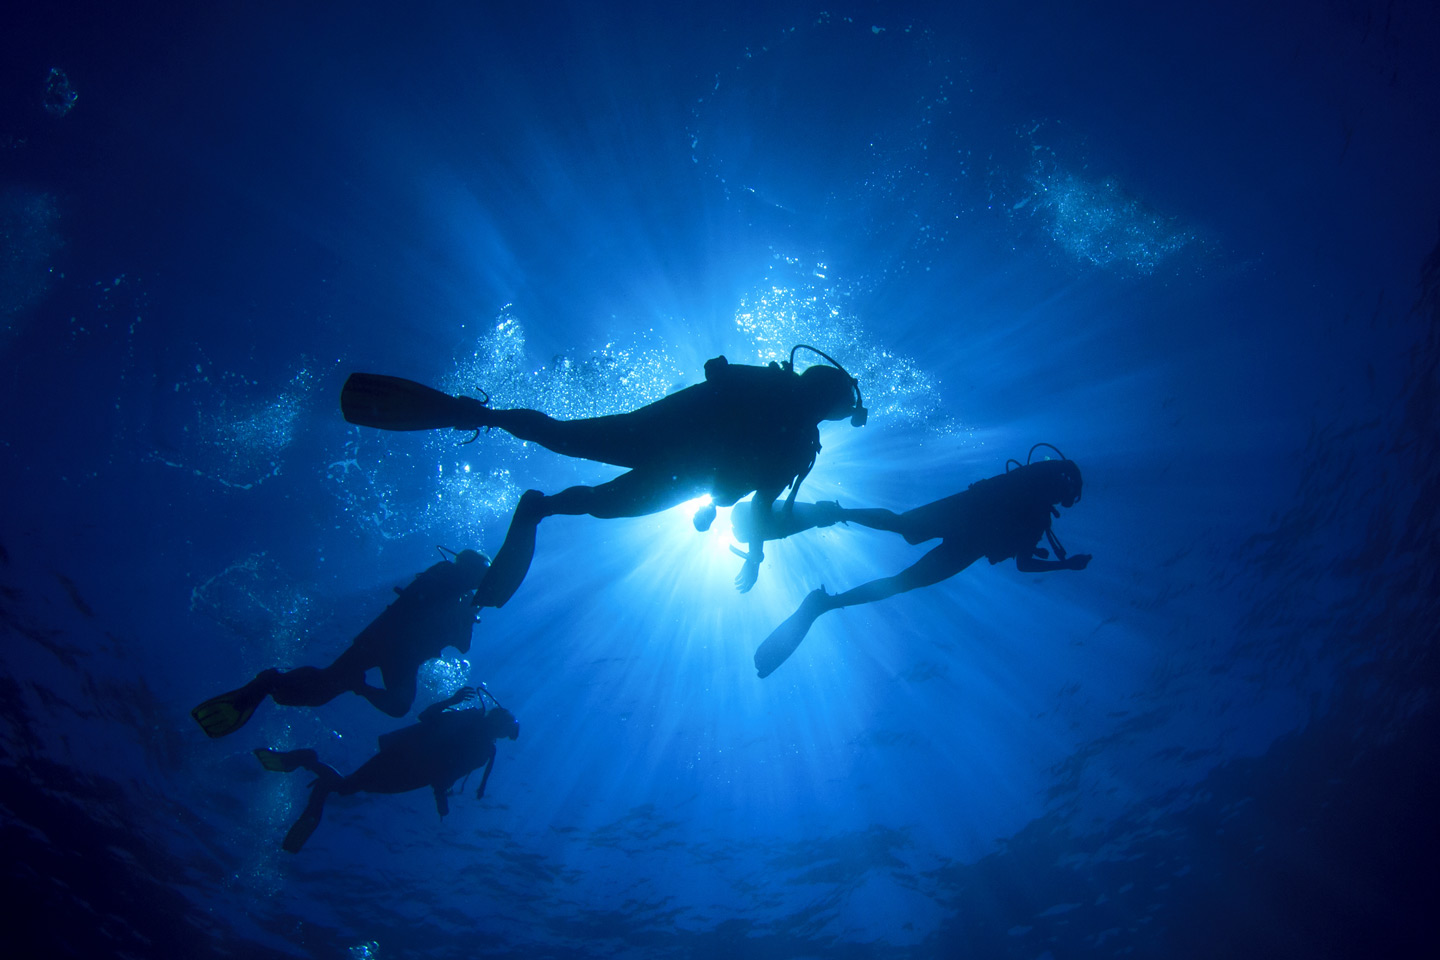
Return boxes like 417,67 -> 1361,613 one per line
255,684 -> 520,853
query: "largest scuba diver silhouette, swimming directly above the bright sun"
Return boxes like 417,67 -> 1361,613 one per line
340,344 -> 867,607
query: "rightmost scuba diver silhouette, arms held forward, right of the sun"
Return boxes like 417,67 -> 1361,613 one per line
754,443 -> 1090,679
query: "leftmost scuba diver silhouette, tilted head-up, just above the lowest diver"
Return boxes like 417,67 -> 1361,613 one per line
190,550 -> 490,738
